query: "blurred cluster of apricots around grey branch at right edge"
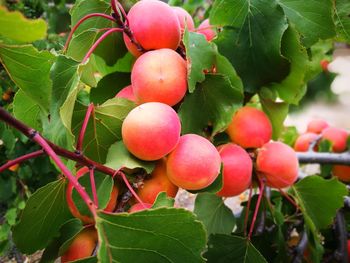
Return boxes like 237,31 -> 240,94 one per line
294,119 -> 350,183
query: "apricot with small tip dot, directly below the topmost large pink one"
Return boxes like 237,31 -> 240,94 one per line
131,49 -> 187,106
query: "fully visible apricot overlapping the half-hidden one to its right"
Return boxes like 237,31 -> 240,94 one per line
167,134 -> 221,190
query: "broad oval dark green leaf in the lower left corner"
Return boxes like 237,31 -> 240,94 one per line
13,179 -> 71,254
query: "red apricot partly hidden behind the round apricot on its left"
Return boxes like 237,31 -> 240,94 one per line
217,143 -> 253,197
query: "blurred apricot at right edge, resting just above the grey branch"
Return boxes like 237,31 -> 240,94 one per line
322,127 -> 349,152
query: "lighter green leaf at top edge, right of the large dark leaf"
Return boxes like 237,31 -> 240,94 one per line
278,0 -> 335,47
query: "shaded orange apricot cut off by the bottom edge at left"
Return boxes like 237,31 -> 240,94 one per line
61,227 -> 98,263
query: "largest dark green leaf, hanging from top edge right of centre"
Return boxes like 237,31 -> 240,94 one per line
213,0 -> 289,93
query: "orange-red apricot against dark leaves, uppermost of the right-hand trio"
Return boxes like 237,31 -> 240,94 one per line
226,106 -> 272,148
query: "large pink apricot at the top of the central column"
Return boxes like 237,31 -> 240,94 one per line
123,0 -> 181,56
